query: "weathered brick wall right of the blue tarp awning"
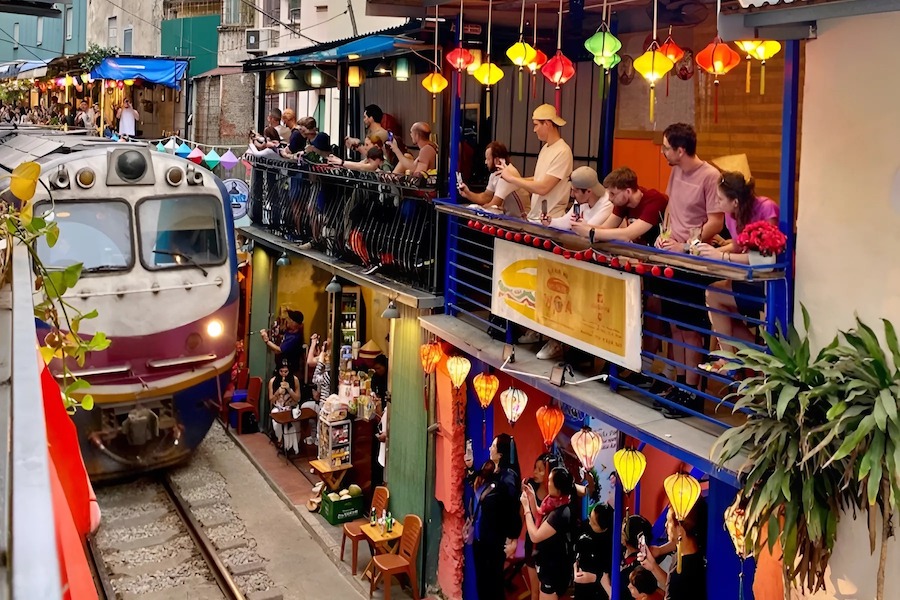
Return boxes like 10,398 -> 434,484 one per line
193,73 -> 256,148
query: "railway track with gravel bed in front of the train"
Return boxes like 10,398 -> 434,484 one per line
89,474 -> 250,600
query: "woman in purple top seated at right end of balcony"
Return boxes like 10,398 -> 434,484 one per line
694,171 -> 779,372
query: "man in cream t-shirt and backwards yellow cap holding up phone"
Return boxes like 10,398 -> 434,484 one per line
500,104 -> 574,221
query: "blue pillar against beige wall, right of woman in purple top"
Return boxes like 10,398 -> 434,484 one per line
766,40 -> 800,333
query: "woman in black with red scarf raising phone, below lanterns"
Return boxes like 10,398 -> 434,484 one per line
520,467 -> 575,600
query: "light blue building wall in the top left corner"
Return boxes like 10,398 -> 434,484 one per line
0,0 -> 88,62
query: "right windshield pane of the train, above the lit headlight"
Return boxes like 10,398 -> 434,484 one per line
137,196 -> 228,269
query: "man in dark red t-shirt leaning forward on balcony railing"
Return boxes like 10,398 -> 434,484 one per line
594,167 -> 669,245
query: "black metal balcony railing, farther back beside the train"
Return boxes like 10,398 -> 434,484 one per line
249,157 -> 443,298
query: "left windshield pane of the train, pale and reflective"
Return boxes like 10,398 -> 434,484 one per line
34,200 -> 134,273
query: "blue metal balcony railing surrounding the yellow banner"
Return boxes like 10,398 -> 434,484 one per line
441,203 -> 790,427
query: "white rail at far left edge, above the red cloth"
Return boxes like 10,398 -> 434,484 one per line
0,245 -> 62,600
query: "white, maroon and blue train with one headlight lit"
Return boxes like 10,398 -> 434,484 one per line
0,131 -> 239,481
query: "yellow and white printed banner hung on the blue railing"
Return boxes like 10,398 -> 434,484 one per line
491,240 -> 641,371
